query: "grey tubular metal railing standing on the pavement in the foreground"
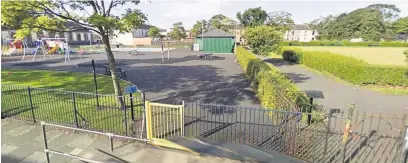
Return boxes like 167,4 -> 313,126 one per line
41,121 -> 149,163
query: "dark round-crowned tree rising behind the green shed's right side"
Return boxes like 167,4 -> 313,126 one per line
237,7 -> 268,27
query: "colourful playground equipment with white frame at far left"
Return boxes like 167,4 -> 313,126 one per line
32,38 -> 70,63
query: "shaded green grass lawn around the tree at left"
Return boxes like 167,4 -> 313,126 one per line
1,69 -> 142,135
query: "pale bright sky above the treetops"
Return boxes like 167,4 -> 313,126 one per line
130,0 -> 408,29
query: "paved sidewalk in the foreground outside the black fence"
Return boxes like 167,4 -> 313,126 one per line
1,119 -> 302,163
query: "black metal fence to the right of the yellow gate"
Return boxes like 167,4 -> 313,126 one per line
184,102 -> 406,163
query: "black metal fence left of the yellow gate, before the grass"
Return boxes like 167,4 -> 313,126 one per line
1,85 -> 144,137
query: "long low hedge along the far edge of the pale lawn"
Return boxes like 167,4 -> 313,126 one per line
281,40 -> 408,47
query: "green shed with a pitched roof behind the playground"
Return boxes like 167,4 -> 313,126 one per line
195,29 -> 235,53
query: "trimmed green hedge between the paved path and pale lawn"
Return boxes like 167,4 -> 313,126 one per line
282,48 -> 408,87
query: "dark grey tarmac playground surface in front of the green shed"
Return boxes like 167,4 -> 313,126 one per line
2,48 -> 259,106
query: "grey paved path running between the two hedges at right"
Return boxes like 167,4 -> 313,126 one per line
265,59 -> 408,116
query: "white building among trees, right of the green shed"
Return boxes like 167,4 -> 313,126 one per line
283,24 -> 318,42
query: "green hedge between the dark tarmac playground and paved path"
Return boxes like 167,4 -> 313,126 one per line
236,47 -> 308,109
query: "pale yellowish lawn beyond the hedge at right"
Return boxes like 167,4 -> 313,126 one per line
296,46 -> 408,66
